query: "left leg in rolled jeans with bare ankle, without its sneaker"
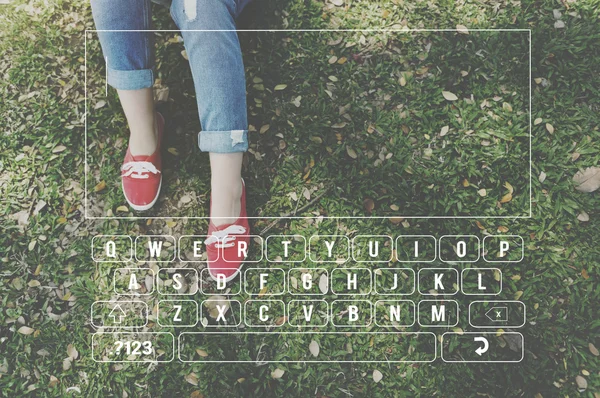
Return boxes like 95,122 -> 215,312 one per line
91,0 -> 157,156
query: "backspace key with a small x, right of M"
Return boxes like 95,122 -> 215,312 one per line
469,300 -> 527,328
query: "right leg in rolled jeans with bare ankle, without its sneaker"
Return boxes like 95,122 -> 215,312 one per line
171,0 -> 248,226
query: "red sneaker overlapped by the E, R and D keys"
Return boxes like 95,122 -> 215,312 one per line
204,180 -> 250,282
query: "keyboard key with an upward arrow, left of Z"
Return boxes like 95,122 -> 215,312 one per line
91,300 -> 148,329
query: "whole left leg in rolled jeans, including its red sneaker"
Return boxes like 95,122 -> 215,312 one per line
91,0 -> 164,211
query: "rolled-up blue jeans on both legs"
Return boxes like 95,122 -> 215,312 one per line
91,0 -> 249,153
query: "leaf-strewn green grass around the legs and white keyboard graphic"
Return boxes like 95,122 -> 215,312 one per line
0,0 -> 600,397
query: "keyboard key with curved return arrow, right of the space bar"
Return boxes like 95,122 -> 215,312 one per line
441,332 -> 524,362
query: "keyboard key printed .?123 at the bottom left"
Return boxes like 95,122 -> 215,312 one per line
92,332 -> 175,362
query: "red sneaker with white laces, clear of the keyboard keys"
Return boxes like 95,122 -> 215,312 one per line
121,112 -> 165,211
